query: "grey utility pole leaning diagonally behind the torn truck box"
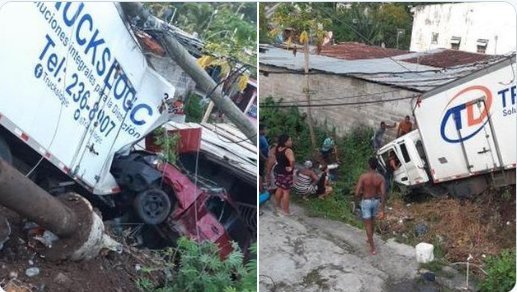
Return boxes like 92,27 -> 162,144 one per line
120,2 -> 257,144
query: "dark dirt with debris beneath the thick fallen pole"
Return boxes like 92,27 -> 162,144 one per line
0,207 -> 161,292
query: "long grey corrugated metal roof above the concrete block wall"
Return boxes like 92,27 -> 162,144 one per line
259,48 -> 504,92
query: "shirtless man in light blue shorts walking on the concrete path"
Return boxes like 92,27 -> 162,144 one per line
355,157 -> 386,255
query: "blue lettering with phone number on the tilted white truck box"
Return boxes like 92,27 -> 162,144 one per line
35,2 -> 154,133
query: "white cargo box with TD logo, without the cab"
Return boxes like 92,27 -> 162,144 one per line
414,56 -> 517,183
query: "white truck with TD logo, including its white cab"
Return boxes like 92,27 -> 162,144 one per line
377,55 -> 517,197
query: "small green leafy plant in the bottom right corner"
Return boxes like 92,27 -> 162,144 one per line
480,250 -> 515,292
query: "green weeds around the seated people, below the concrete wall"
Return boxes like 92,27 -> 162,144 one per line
260,97 -> 373,226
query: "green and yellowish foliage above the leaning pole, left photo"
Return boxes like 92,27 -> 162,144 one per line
146,2 -> 257,85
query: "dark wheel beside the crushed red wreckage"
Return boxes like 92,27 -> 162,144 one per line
134,189 -> 172,225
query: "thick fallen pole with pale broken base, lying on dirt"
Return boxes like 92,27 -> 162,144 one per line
0,159 -> 117,260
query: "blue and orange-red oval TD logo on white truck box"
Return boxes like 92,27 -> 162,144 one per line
440,85 -> 492,143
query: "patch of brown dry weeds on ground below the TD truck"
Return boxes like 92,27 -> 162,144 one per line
379,191 -> 516,264
